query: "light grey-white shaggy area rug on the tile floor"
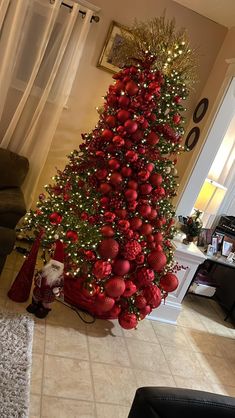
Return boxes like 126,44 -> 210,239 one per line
0,313 -> 34,418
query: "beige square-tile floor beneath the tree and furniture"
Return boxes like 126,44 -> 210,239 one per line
0,247 -> 235,418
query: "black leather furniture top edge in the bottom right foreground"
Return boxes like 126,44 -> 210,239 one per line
128,387 -> 235,418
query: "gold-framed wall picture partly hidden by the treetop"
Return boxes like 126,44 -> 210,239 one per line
97,21 -> 129,73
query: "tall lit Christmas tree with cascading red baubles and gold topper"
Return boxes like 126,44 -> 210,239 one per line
20,17 -> 194,329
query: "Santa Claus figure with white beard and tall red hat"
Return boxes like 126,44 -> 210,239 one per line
26,241 -> 64,318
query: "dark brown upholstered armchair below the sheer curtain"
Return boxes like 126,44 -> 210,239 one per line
0,148 -> 29,273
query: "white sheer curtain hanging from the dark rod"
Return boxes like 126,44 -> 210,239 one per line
0,0 -> 93,207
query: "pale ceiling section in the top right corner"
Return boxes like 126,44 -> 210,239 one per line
173,0 -> 235,28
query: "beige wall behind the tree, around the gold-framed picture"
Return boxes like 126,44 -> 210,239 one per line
34,0 -> 227,203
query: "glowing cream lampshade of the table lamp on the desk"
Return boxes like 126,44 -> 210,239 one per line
194,179 -> 227,215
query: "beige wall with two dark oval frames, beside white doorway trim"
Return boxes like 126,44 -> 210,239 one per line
175,27 -> 235,204
